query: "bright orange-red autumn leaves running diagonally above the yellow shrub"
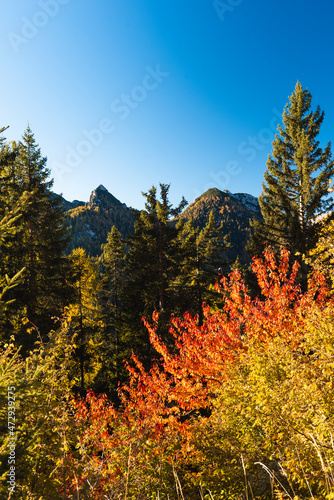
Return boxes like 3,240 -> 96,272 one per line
68,250 -> 330,498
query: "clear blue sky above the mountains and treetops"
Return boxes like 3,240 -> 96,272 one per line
0,0 -> 334,208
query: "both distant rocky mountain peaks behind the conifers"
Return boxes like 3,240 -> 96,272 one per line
58,185 -> 261,262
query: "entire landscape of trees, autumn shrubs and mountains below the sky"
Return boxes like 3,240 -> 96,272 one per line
0,83 -> 334,500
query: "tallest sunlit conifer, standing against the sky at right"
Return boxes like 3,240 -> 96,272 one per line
250,83 -> 334,286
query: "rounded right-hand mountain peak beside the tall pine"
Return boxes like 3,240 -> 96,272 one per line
176,188 -> 261,263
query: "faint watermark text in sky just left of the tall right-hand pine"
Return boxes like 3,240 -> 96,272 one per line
193,108 -> 282,197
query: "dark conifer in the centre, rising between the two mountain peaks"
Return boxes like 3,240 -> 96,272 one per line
122,184 -> 187,359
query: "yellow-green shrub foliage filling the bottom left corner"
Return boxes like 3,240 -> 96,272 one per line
0,329 -> 76,500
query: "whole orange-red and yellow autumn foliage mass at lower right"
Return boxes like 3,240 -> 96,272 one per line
70,250 -> 334,499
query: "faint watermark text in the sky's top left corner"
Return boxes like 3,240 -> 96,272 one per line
7,0 -> 71,53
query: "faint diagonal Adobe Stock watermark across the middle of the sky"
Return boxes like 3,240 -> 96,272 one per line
52,64 -> 170,182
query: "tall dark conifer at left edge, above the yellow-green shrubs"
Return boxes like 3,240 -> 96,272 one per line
0,127 -> 68,345
